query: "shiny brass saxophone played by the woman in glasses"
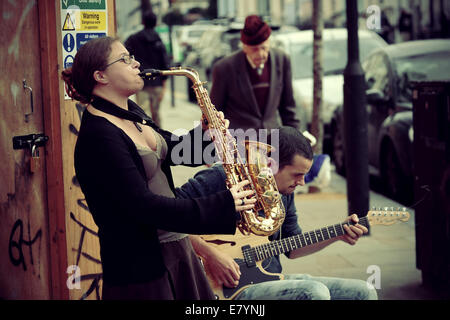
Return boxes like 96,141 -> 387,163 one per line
140,67 -> 286,236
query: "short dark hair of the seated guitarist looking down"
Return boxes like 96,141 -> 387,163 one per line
267,126 -> 314,169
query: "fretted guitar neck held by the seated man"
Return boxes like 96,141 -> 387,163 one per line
243,217 -> 369,261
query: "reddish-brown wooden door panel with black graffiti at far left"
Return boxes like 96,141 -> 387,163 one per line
0,1 -> 51,299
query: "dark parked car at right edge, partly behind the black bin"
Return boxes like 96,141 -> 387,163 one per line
331,40 -> 450,201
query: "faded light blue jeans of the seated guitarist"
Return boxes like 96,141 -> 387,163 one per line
236,274 -> 378,300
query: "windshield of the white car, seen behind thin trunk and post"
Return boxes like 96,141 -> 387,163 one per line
289,38 -> 382,79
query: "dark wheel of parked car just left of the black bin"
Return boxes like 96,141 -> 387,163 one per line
380,142 -> 412,202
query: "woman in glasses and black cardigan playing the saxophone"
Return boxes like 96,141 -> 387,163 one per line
62,37 -> 255,300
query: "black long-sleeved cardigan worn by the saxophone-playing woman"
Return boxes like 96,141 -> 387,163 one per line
75,100 -> 236,285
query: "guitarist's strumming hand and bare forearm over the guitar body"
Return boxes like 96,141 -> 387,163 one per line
189,235 -> 241,288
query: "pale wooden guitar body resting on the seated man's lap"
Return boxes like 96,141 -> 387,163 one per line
201,230 -> 283,300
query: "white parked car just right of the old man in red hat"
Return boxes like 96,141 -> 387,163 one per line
272,28 -> 387,152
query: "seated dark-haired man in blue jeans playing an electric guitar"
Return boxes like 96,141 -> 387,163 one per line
177,127 -> 378,300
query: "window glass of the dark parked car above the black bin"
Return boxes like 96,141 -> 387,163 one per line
394,51 -> 450,102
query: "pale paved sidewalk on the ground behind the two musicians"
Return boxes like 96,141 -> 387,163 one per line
157,90 -> 438,300
